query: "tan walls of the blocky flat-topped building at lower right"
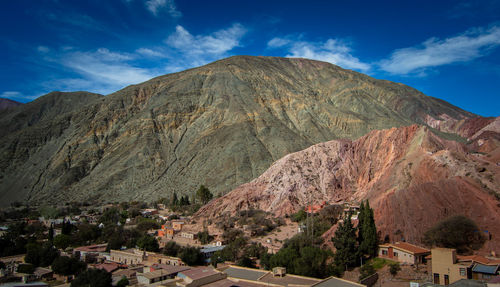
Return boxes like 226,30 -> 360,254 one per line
431,248 -> 468,285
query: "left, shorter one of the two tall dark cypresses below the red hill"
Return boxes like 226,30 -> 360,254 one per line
332,213 -> 358,270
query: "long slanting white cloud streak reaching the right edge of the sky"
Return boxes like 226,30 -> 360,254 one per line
379,26 -> 500,75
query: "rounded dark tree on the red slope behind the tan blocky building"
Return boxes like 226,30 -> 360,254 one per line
423,215 -> 486,254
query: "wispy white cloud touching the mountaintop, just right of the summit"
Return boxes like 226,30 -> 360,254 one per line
267,38 -> 371,72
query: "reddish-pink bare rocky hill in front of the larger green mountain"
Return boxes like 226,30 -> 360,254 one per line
196,124 -> 500,251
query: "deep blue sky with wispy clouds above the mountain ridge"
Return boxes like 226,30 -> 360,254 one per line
0,0 -> 500,116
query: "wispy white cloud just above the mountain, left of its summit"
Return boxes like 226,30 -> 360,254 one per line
165,23 -> 247,68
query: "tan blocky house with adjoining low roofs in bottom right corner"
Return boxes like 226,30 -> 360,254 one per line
430,248 -> 500,285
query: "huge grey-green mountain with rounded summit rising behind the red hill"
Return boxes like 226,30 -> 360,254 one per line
0,56 -> 484,204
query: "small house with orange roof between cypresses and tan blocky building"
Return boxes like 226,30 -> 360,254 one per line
378,242 -> 431,265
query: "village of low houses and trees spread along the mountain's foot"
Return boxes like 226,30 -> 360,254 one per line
0,199 -> 500,287
